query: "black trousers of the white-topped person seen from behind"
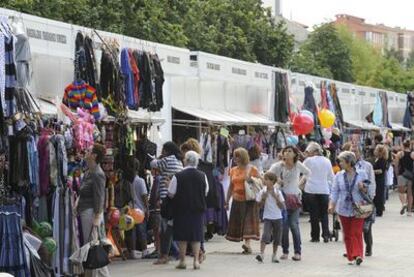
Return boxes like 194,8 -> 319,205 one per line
307,193 -> 329,240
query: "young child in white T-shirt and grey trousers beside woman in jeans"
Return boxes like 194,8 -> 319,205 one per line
256,172 -> 285,263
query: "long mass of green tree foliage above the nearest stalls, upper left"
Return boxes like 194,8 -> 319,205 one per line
0,0 -> 293,67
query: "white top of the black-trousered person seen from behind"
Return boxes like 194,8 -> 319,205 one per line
303,156 -> 334,194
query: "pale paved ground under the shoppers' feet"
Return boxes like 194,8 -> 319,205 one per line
109,192 -> 414,277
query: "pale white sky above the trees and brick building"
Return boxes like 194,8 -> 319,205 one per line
262,0 -> 414,30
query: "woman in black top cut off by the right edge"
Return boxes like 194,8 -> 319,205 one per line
396,140 -> 414,216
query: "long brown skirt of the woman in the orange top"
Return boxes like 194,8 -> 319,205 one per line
226,200 -> 260,242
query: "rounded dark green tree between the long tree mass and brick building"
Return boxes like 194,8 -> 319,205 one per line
291,23 -> 353,82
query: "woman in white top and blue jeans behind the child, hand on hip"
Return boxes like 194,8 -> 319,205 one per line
269,146 -> 310,261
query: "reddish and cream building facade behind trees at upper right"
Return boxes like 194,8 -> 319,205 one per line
334,14 -> 414,59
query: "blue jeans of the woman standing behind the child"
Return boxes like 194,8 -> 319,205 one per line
282,209 -> 302,255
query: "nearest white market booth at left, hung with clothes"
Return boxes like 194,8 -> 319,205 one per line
0,9 -> 189,276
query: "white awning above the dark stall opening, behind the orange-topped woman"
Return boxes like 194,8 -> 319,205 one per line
173,107 -> 285,126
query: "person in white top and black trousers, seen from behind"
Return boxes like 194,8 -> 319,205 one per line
303,142 -> 334,243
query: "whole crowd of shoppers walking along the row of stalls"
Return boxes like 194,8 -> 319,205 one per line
77,133 -> 414,270
